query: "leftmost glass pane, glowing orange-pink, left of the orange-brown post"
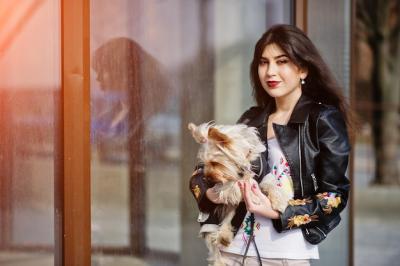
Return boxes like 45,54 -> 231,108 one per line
0,0 -> 60,265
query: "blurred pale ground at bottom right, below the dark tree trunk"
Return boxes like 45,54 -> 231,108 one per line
354,187 -> 400,266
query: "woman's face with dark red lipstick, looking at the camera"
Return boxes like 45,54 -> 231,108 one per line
258,44 -> 307,98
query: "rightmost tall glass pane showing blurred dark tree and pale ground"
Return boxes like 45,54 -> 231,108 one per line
353,0 -> 400,265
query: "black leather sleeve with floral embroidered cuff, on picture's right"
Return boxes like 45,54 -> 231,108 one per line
273,107 -> 350,232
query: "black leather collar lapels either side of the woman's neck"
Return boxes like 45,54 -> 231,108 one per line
251,93 -> 314,127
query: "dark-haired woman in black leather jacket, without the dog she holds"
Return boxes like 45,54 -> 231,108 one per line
190,25 -> 350,265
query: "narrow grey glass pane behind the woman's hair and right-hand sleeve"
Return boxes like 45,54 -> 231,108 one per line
307,0 -> 351,265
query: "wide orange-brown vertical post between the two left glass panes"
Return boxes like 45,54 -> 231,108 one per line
60,0 -> 91,266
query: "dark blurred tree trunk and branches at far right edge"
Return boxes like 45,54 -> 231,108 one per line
357,0 -> 400,184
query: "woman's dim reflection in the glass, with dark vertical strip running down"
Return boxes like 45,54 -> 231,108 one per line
92,37 -> 170,254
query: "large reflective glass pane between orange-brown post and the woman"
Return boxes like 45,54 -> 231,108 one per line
90,0 -> 292,265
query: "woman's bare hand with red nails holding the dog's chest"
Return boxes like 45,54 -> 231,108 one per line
238,181 -> 279,219
